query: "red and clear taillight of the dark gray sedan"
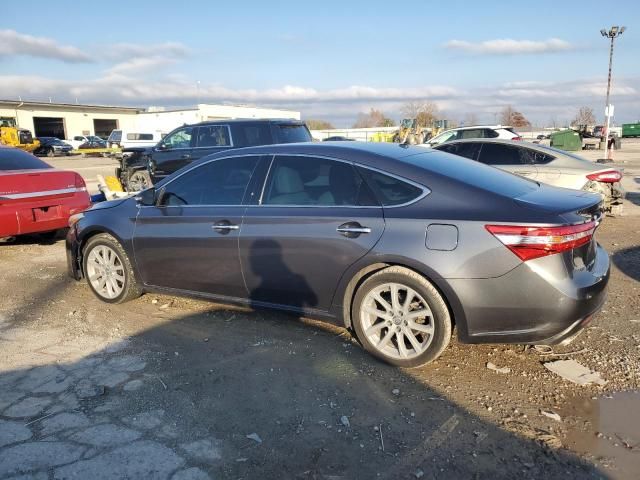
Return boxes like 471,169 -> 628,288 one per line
485,222 -> 598,262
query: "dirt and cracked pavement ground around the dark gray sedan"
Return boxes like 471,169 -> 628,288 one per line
0,141 -> 640,480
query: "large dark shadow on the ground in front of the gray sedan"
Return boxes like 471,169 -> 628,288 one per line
0,274 -> 606,479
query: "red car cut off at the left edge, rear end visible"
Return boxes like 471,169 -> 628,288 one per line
0,145 -> 91,238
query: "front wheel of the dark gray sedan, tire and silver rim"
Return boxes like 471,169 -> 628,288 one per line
83,233 -> 142,303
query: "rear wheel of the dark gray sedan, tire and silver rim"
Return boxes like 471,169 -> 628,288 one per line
351,267 -> 451,367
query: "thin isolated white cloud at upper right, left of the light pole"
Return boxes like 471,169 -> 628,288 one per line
444,38 -> 575,55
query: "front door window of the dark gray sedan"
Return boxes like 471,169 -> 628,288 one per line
160,156 -> 260,207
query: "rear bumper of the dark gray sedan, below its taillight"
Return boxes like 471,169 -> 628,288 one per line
448,245 -> 610,345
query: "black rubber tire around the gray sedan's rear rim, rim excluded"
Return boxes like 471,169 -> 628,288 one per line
351,266 -> 452,368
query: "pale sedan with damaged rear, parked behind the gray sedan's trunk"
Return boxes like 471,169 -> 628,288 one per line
434,139 -> 625,212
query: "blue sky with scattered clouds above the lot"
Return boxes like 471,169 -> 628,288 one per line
0,0 -> 640,126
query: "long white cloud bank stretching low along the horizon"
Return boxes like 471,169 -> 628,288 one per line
0,73 -> 640,126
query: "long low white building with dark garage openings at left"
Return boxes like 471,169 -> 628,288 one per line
0,100 -> 300,139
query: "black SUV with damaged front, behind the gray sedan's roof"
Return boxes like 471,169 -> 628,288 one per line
116,119 -> 312,190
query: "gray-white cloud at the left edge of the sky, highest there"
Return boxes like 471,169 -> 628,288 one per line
0,30 -> 93,63
